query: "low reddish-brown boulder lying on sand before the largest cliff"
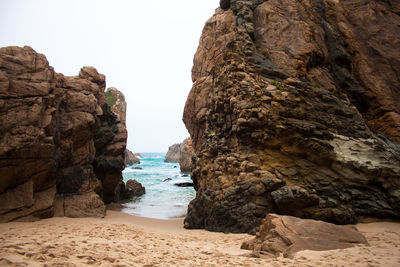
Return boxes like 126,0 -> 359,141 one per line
241,214 -> 368,257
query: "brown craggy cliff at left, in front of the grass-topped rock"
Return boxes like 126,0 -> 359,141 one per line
0,46 -> 126,222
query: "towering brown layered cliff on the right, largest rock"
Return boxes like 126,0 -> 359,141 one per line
183,0 -> 400,233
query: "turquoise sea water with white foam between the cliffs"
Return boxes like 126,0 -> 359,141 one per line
122,153 -> 196,219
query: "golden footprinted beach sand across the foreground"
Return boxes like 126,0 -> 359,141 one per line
0,211 -> 400,267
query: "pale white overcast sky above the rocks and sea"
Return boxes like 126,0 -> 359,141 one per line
0,0 -> 219,152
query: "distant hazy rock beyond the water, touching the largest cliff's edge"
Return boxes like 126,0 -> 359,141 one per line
165,138 -> 194,172
